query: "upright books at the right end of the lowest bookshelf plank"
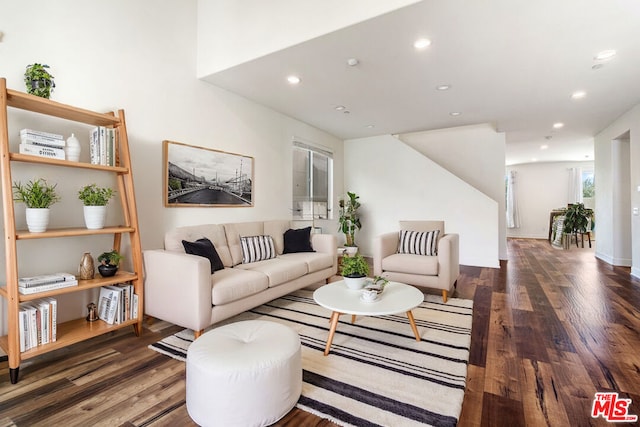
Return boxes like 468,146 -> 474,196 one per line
98,283 -> 138,325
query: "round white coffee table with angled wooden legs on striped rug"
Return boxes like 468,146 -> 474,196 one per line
313,280 -> 424,356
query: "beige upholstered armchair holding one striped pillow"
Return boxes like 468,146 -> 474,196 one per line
373,221 -> 460,302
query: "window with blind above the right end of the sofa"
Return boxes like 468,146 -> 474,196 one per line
292,141 -> 333,220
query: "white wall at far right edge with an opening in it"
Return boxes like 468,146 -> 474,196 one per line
595,105 -> 640,277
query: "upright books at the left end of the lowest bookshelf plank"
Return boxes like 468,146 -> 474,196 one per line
18,298 -> 58,352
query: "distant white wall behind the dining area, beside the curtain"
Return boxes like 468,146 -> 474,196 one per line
507,161 -> 600,239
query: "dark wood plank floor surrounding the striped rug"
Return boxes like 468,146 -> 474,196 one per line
0,239 -> 640,427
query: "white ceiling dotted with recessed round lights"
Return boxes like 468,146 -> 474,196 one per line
204,0 -> 640,164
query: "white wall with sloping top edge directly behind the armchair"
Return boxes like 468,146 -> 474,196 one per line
341,135 -> 499,267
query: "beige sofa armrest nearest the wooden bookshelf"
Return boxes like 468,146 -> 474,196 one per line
143,250 -> 212,331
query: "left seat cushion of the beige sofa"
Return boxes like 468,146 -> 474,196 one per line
211,268 -> 269,305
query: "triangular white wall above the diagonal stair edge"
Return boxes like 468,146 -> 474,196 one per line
399,124 -> 507,259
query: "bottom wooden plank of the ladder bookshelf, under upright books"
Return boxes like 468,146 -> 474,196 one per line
0,318 -> 138,360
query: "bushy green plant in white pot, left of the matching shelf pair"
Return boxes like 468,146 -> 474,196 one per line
13,178 -> 60,233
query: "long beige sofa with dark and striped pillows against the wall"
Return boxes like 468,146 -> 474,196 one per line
143,220 -> 337,336
